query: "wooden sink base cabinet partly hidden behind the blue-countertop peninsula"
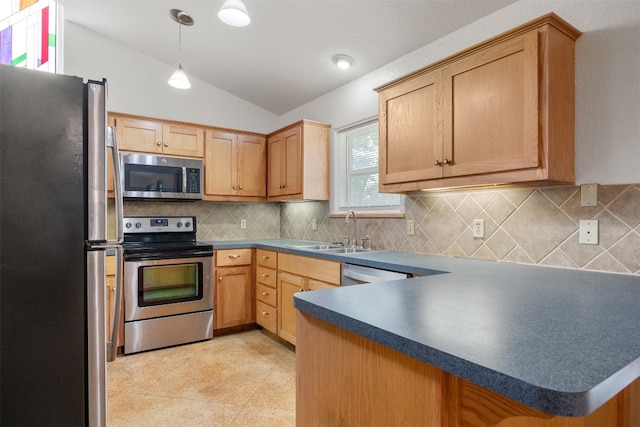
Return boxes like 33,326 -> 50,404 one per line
278,253 -> 341,345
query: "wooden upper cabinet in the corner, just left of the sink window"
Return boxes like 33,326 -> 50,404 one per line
267,120 -> 330,201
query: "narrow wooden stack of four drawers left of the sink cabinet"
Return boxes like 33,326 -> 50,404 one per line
256,249 -> 278,334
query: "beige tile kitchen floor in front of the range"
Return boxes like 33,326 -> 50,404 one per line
108,330 -> 295,427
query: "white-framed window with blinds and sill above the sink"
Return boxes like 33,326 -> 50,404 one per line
331,119 -> 404,216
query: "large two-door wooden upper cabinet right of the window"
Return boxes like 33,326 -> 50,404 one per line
376,14 -> 580,192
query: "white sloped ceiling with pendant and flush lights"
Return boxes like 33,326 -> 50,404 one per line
59,0 -> 515,114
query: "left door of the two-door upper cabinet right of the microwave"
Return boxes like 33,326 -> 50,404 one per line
204,131 -> 238,196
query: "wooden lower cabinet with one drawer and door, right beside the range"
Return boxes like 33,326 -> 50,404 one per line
214,249 -> 255,330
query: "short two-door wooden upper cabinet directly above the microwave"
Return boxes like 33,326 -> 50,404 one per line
115,115 -> 204,158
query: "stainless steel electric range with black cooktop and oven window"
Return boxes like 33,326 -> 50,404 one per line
122,216 -> 214,354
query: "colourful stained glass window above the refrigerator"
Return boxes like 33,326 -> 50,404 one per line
0,0 -> 57,73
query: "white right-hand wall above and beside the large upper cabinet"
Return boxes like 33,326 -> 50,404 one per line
278,0 -> 640,184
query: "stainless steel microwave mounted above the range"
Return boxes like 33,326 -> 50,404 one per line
120,153 -> 204,200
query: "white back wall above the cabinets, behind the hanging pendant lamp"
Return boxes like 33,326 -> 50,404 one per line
63,21 -> 276,133
